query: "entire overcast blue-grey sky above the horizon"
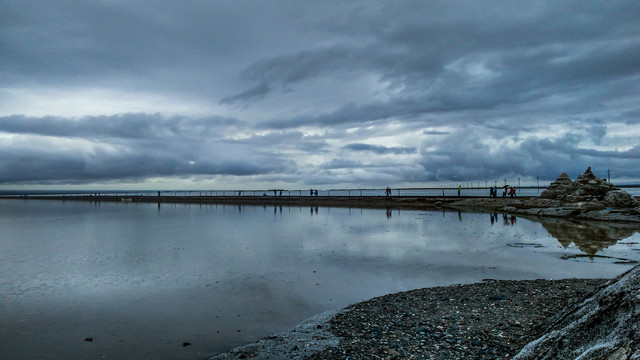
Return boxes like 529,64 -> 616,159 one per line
0,0 -> 640,189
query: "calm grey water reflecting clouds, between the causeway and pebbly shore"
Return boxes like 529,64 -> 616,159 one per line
0,200 -> 640,359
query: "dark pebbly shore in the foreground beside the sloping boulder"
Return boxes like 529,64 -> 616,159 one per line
212,279 -> 607,360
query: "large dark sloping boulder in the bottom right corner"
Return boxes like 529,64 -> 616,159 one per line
513,266 -> 640,360
